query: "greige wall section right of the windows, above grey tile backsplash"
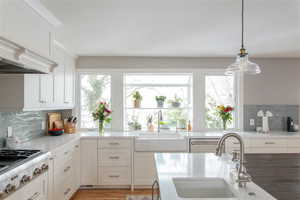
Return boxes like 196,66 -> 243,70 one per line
244,59 -> 300,104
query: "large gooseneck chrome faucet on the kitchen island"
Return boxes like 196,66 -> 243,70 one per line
216,133 -> 252,187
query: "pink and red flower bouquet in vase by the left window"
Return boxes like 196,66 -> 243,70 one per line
92,102 -> 112,133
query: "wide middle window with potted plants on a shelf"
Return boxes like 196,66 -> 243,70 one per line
124,73 -> 192,131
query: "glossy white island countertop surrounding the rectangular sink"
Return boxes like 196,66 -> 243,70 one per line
155,153 -> 275,200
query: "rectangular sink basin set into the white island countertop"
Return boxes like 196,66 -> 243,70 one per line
173,178 -> 235,198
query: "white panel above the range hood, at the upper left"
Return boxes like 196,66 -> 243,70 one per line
1,0 -> 54,56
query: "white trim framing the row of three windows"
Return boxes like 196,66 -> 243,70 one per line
73,68 -> 244,132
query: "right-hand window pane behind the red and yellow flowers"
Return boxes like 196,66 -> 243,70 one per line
205,75 -> 236,129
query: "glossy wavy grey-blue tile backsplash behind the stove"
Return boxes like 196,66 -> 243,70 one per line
0,110 -> 71,147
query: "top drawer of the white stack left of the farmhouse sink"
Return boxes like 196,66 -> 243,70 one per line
98,138 -> 131,149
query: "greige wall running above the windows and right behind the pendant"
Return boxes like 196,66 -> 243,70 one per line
77,57 -> 300,104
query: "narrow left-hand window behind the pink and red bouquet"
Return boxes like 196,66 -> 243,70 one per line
79,73 -> 111,129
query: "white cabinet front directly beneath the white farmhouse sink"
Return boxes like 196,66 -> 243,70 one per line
133,152 -> 157,186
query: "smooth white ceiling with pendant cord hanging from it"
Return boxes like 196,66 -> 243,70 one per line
41,0 -> 300,57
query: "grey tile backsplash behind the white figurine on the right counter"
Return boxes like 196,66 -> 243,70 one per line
244,105 -> 299,131
